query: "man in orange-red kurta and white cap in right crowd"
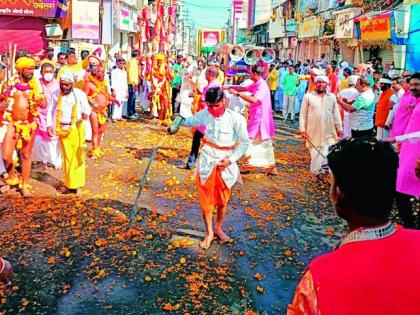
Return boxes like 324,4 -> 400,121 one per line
375,77 -> 394,140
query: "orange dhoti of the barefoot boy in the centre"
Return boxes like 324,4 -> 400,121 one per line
195,166 -> 231,214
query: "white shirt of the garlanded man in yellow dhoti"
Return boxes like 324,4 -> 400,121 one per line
47,88 -> 92,127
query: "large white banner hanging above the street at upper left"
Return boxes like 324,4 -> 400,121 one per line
71,0 -> 99,39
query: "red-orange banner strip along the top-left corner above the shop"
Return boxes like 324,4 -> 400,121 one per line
0,0 -> 65,17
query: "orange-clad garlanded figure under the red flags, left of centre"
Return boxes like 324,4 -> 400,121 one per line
150,53 -> 173,124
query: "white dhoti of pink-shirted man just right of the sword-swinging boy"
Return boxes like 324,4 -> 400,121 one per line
243,138 -> 276,171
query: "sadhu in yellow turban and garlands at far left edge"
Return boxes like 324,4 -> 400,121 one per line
0,57 -> 47,197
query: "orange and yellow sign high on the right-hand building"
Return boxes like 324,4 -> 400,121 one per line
359,13 -> 391,40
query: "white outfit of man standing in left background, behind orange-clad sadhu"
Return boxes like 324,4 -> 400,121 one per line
111,68 -> 128,119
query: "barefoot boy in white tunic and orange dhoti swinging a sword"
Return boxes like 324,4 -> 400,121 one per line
168,87 -> 249,249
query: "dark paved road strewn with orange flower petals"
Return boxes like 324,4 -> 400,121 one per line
0,116 -> 343,314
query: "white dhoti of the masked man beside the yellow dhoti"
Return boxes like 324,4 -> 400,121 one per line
32,133 -> 63,168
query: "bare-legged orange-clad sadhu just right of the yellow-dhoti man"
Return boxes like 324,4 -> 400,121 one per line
83,62 -> 120,159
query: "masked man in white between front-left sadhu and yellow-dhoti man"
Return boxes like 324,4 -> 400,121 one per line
32,62 -> 62,170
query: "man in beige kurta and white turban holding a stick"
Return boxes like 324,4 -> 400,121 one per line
299,74 -> 343,179
